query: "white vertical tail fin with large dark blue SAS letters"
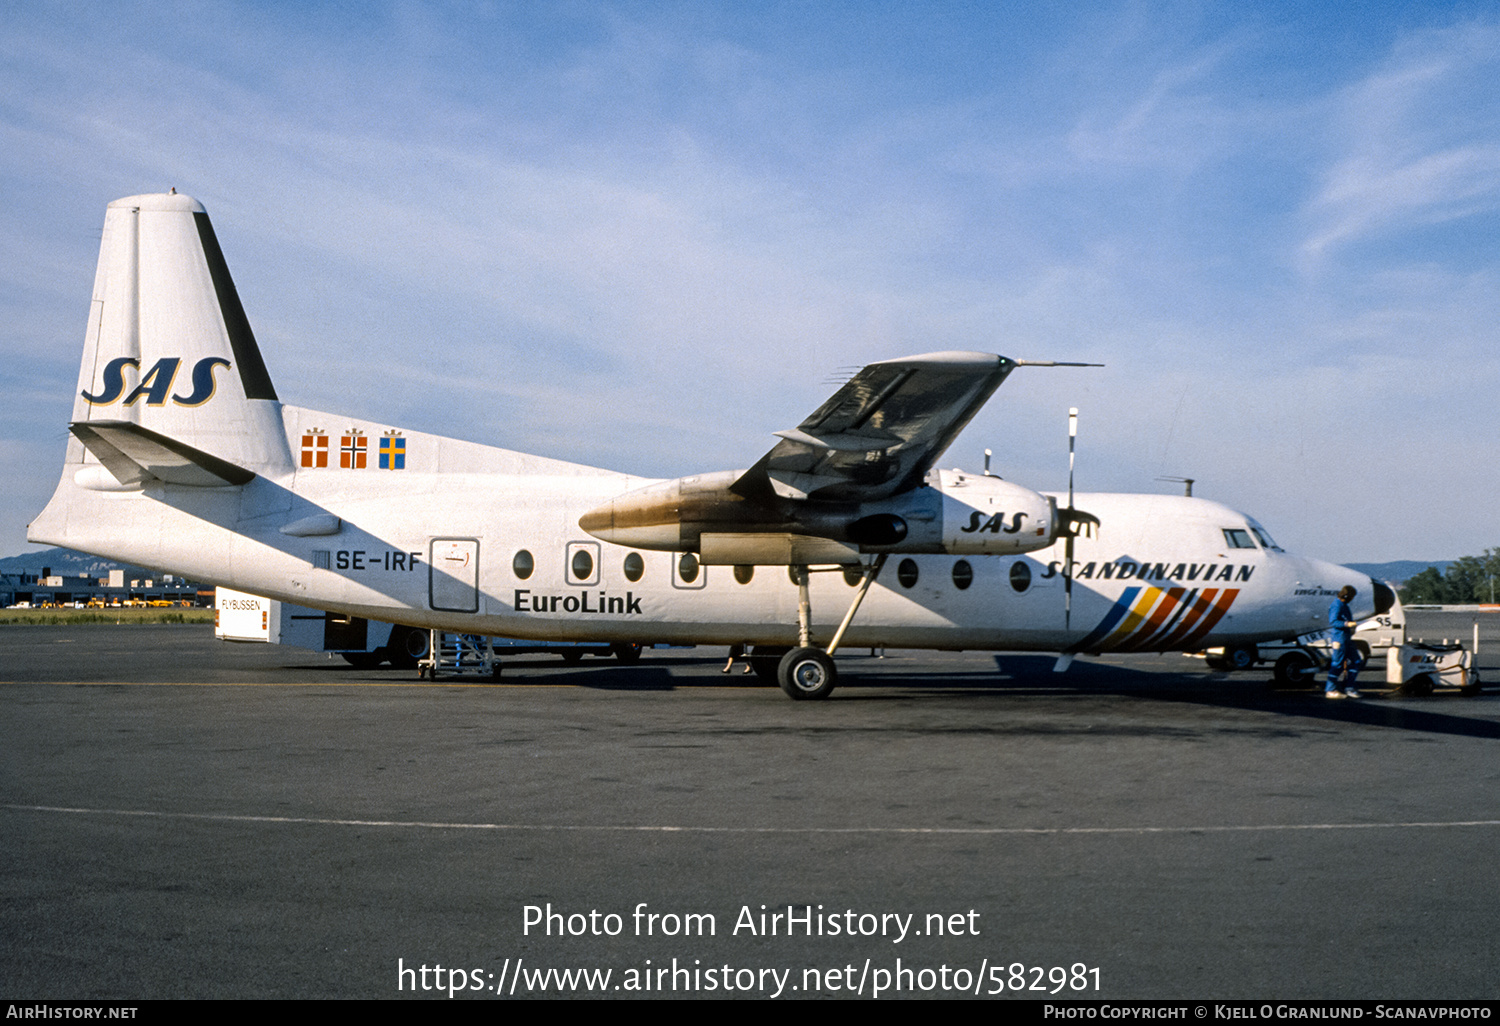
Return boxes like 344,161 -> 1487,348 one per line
68,194 -> 291,483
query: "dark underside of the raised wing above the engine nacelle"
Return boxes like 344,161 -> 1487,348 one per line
731,353 -> 1016,503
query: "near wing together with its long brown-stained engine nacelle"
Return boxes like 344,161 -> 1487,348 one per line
579,353 -> 1056,566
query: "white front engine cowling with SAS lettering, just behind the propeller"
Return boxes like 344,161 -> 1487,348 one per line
936,471 -> 1059,555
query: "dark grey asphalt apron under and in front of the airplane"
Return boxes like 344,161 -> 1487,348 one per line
0,614 -> 1500,1001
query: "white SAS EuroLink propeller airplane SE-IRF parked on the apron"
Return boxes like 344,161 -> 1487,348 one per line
27,192 -> 1394,699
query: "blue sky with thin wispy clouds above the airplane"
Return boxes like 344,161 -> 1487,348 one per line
0,2 -> 1500,561
